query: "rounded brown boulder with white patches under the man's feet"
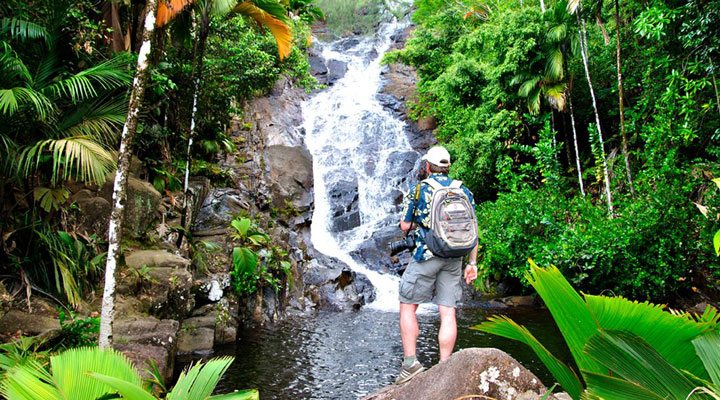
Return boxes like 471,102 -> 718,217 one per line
364,348 -> 556,400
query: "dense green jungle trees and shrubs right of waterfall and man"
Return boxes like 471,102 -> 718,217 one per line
386,0 -> 720,302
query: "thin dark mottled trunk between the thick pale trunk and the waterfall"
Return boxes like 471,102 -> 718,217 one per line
176,4 -> 212,247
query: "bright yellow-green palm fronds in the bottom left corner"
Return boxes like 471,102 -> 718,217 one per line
0,347 -> 259,400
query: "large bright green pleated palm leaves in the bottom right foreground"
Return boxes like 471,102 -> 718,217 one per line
474,261 -> 720,399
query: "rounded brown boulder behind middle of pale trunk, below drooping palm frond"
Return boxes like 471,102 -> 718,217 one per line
101,174 -> 162,239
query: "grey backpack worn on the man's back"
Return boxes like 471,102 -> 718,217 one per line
423,178 -> 478,258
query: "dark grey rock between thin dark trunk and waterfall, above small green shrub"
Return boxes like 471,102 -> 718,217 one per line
193,188 -> 252,233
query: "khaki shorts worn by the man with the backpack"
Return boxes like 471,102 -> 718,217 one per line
400,257 -> 462,307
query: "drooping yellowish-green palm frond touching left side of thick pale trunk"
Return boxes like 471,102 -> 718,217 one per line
18,136 -> 116,185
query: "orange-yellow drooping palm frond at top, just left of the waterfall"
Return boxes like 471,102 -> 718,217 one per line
233,0 -> 292,60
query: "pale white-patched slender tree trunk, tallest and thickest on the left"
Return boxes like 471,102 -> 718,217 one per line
98,0 -> 157,348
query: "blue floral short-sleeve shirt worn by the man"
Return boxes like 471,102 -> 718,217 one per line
403,174 -> 475,261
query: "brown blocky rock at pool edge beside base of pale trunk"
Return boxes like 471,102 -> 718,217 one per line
113,317 -> 180,380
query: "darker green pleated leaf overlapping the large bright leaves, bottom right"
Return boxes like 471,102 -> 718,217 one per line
585,331 -> 696,399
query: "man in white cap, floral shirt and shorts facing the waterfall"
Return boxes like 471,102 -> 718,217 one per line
395,146 -> 478,384
